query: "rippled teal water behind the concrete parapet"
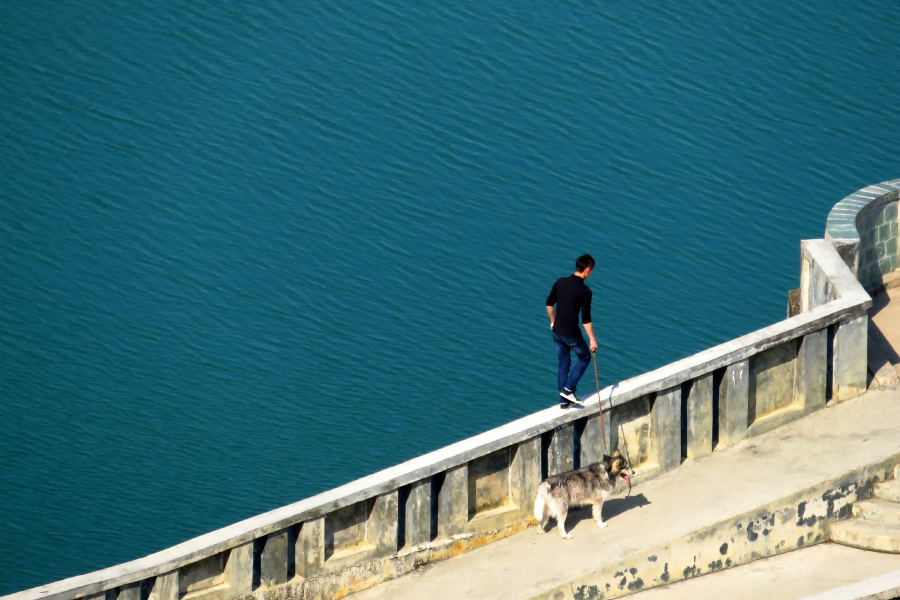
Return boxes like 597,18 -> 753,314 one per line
0,0 -> 900,594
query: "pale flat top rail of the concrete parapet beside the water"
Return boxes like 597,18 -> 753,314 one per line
5,240 -> 871,600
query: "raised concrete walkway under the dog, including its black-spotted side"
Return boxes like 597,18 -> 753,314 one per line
348,391 -> 900,600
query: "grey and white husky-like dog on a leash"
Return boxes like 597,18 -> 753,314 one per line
534,449 -> 634,540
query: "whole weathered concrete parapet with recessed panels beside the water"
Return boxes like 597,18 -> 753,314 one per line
8,240 -> 871,600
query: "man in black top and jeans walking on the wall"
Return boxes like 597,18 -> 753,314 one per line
547,254 -> 597,409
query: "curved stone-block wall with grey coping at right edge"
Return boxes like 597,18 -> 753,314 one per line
825,179 -> 900,292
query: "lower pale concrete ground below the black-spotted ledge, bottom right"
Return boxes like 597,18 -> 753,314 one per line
633,544 -> 900,600
